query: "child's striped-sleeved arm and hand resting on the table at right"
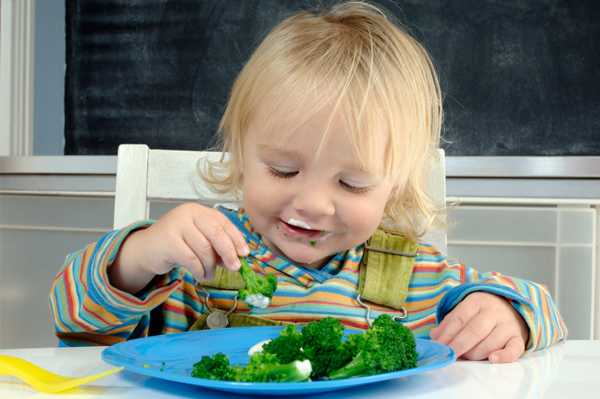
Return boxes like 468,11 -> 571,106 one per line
422,257 -> 567,362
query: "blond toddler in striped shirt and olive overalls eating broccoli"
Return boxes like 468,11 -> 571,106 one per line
50,2 -> 566,363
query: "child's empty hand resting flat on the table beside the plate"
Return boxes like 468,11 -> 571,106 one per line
430,292 -> 529,363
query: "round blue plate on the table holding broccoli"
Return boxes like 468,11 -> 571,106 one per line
102,327 -> 456,396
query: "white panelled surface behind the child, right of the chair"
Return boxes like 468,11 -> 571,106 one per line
448,204 -> 597,339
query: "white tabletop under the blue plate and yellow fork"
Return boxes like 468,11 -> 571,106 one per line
0,341 -> 600,399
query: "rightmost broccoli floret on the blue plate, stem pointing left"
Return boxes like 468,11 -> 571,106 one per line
329,315 -> 418,380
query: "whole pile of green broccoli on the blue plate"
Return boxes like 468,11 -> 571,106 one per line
192,315 -> 418,382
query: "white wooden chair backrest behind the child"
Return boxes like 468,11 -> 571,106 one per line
113,144 -> 446,253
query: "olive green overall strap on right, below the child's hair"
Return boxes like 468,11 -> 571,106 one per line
358,230 -> 419,310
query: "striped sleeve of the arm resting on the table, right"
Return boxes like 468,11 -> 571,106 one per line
437,260 -> 567,354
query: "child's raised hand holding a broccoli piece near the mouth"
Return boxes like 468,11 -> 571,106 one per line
109,204 -> 250,293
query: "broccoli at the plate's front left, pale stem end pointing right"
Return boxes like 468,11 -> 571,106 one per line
192,352 -> 312,382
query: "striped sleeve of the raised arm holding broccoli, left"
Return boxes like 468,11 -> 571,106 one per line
49,221 -> 182,346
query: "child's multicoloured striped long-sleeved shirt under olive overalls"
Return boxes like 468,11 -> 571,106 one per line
49,208 -> 566,353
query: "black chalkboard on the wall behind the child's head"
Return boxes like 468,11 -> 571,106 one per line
65,0 -> 600,156
